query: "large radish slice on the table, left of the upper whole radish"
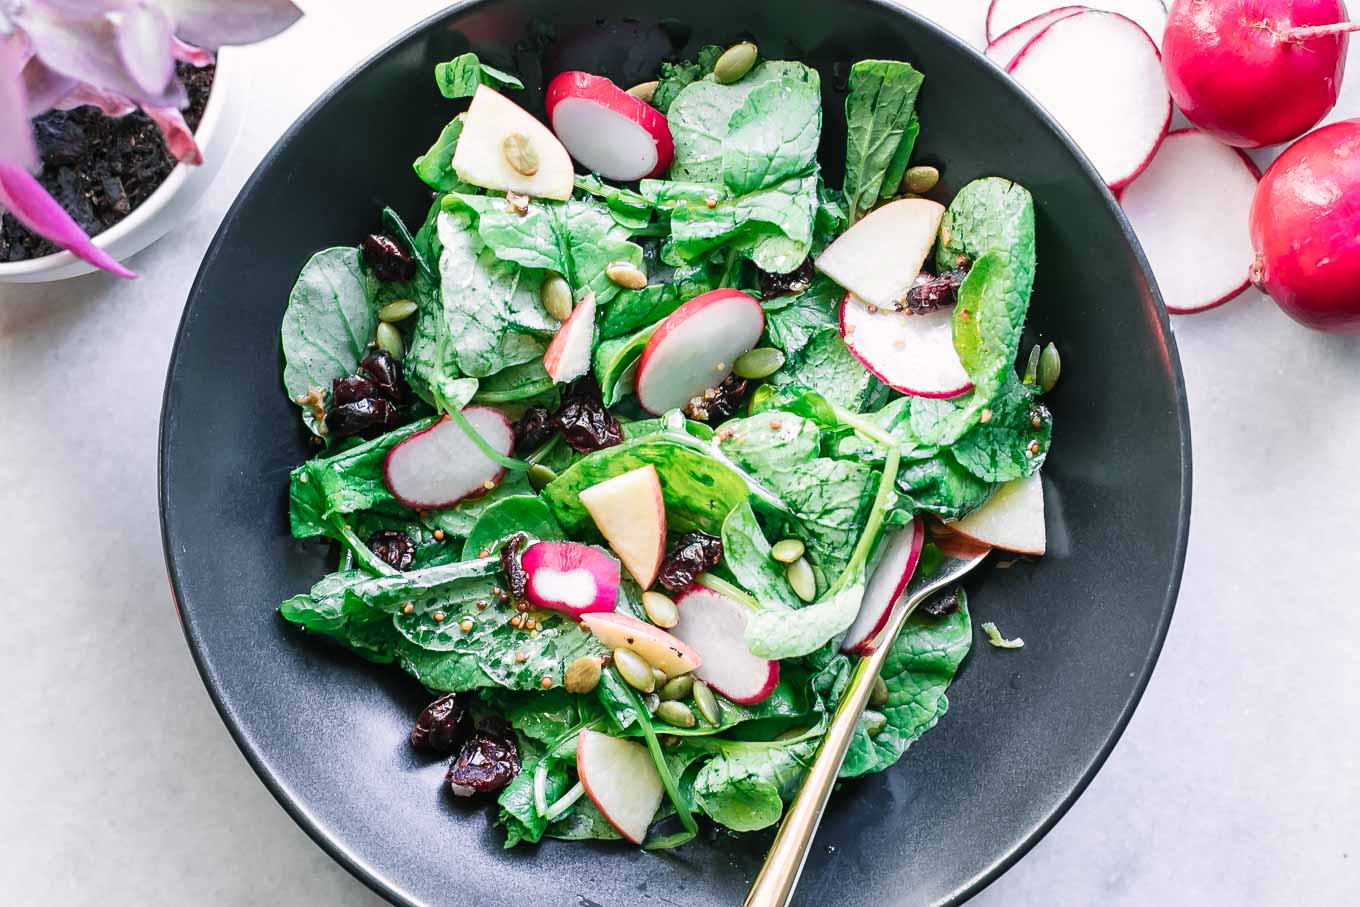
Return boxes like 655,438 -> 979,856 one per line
1009,10 -> 1171,189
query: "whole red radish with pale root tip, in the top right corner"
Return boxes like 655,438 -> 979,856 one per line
1161,0 -> 1360,148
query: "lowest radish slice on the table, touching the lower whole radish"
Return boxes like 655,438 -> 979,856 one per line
1119,129 -> 1261,314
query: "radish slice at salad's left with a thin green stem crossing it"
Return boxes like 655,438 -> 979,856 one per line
382,407 -> 514,509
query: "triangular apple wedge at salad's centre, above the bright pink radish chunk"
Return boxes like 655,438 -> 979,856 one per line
581,464 -> 666,589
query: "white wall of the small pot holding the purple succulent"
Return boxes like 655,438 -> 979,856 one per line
0,50 -> 250,283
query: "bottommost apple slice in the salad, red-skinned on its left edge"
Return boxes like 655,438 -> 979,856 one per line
577,729 -> 664,844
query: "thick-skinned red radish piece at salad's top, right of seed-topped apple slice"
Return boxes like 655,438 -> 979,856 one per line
544,72 -> 675,182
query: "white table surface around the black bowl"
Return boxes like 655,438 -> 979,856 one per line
0,0 -> 1360,907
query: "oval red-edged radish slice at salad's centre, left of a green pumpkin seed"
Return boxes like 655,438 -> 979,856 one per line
624,290 -> 764,416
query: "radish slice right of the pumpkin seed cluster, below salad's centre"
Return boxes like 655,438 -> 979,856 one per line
670,586 -> 779,704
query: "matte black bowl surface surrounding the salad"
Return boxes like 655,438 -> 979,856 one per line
160,0 -> 1190,907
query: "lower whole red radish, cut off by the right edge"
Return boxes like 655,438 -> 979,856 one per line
1251,120 -> 1360,333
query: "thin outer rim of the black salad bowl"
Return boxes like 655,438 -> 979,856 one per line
156,0 -> 1191,907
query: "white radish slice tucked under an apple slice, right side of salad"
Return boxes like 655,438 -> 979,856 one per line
840,292 -> 972,398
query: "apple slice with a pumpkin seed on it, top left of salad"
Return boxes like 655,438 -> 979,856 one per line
453,86 -> 577,201
